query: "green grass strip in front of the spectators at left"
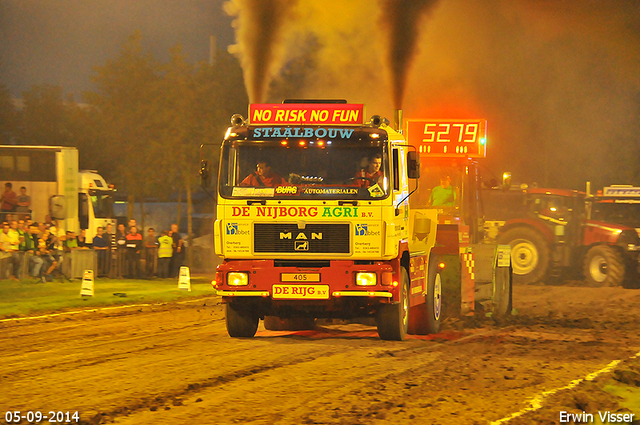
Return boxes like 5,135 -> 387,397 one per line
0,278 -> 216,318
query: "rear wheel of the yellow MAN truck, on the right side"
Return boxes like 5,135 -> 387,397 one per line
409,256 -> 442,335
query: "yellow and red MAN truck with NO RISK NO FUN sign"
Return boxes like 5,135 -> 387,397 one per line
201,101 -> 508,340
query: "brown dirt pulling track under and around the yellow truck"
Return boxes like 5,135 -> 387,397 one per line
0,285 -> 640,424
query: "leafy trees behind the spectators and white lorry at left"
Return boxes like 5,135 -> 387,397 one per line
0,32 -> 248,264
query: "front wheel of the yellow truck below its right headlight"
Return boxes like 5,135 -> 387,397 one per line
376,267 -> 409,341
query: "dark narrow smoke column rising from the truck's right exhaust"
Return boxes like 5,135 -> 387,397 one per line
380,0 -> 437,109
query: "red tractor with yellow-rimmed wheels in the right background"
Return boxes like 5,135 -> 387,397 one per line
498,188 -> 640,286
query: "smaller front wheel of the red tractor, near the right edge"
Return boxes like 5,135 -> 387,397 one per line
584,245 -> 625,287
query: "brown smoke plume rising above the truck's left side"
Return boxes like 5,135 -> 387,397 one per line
224,0 -> 297,103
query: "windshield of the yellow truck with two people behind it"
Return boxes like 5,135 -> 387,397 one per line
219,140 -> 390,199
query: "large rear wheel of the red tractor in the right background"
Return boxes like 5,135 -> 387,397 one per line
498,227 -> 549,284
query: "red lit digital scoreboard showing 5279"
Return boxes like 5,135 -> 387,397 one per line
406,119 -> 487,158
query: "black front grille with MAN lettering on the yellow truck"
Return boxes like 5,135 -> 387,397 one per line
253,223 -> 350,254
